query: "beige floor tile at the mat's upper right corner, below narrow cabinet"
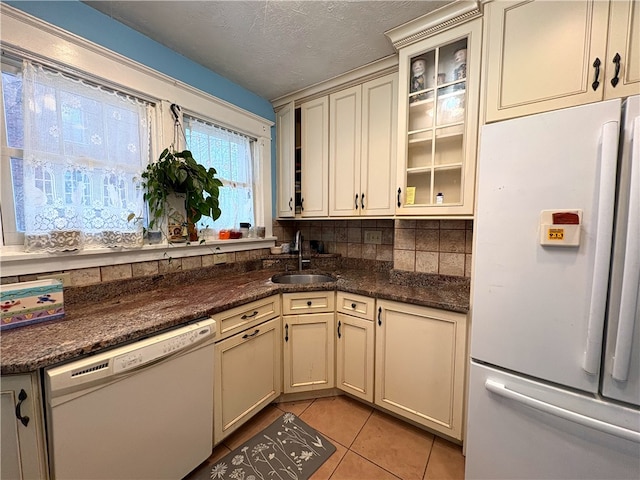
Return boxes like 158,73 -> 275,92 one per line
300,395 -> 373,447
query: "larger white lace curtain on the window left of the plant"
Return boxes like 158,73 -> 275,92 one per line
23,61 -> 153,252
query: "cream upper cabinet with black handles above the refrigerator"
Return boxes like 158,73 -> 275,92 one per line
484,0 -> 640,122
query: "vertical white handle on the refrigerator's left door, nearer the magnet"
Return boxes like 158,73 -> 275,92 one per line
582,122 -> 619,375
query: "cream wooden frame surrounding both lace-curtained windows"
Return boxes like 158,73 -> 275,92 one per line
0,3 -> 275,277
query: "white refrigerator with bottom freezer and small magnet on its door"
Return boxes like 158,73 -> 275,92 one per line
465,97 -> 640,480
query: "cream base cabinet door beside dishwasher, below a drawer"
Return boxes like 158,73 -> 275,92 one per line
213,317 -> 281,445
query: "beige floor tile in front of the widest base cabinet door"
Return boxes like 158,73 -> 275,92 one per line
351,411 -> 434,480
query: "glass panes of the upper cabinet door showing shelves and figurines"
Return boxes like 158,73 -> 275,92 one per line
405,38 -> 467,205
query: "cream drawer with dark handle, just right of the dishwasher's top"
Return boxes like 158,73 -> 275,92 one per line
212,295 -> 280,342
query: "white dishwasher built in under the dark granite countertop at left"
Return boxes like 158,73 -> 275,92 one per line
44,319 -> 215,480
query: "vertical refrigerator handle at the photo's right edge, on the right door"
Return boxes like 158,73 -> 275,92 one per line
611,117 -> 640,382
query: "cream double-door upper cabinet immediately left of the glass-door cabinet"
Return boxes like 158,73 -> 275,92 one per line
329,74 -> 398,217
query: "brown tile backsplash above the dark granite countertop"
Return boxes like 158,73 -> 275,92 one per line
1,219 -> 473,286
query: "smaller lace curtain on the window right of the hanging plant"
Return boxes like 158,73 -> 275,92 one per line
184,115 -> 255,230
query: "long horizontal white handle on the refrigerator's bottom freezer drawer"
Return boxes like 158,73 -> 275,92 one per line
484,379 -> 640,443
